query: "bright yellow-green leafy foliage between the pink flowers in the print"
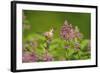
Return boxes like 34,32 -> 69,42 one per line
24,34 -> 90,61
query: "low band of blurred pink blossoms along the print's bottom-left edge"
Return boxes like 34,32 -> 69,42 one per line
22,52 -> 53,63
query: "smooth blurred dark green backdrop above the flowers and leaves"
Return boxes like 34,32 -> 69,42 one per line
23,10 -> 91,39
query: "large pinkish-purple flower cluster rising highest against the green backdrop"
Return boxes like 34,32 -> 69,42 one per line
60,20 -> 83,40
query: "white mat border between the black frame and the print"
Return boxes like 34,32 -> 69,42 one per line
16,4 -> 96,70
